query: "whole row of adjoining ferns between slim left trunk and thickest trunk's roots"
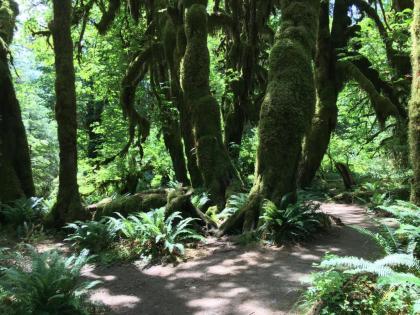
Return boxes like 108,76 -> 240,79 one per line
66,208 -> 204,262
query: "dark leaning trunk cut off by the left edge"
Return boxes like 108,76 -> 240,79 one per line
0,0 -> 35,202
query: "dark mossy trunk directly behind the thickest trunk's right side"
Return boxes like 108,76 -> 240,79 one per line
298,1 -> 338,187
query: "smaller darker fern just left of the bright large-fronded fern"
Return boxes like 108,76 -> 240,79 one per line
65,218 -> 119,253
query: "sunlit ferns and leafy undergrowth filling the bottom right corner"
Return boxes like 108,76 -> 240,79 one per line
300,254 -> 420,315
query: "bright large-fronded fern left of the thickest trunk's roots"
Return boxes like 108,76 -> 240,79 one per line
111,208 -> 204,261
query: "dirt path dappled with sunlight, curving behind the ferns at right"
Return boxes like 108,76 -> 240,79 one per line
85,204 -> 378,315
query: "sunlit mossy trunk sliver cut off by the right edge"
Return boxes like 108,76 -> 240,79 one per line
409,1 -> 420,205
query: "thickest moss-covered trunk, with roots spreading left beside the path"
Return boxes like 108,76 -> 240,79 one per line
222,0 -> 319,232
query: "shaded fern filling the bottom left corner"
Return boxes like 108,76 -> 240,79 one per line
0,249 -> 99,315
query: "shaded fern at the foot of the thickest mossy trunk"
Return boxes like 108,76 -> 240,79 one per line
259,200 -> 330,245
